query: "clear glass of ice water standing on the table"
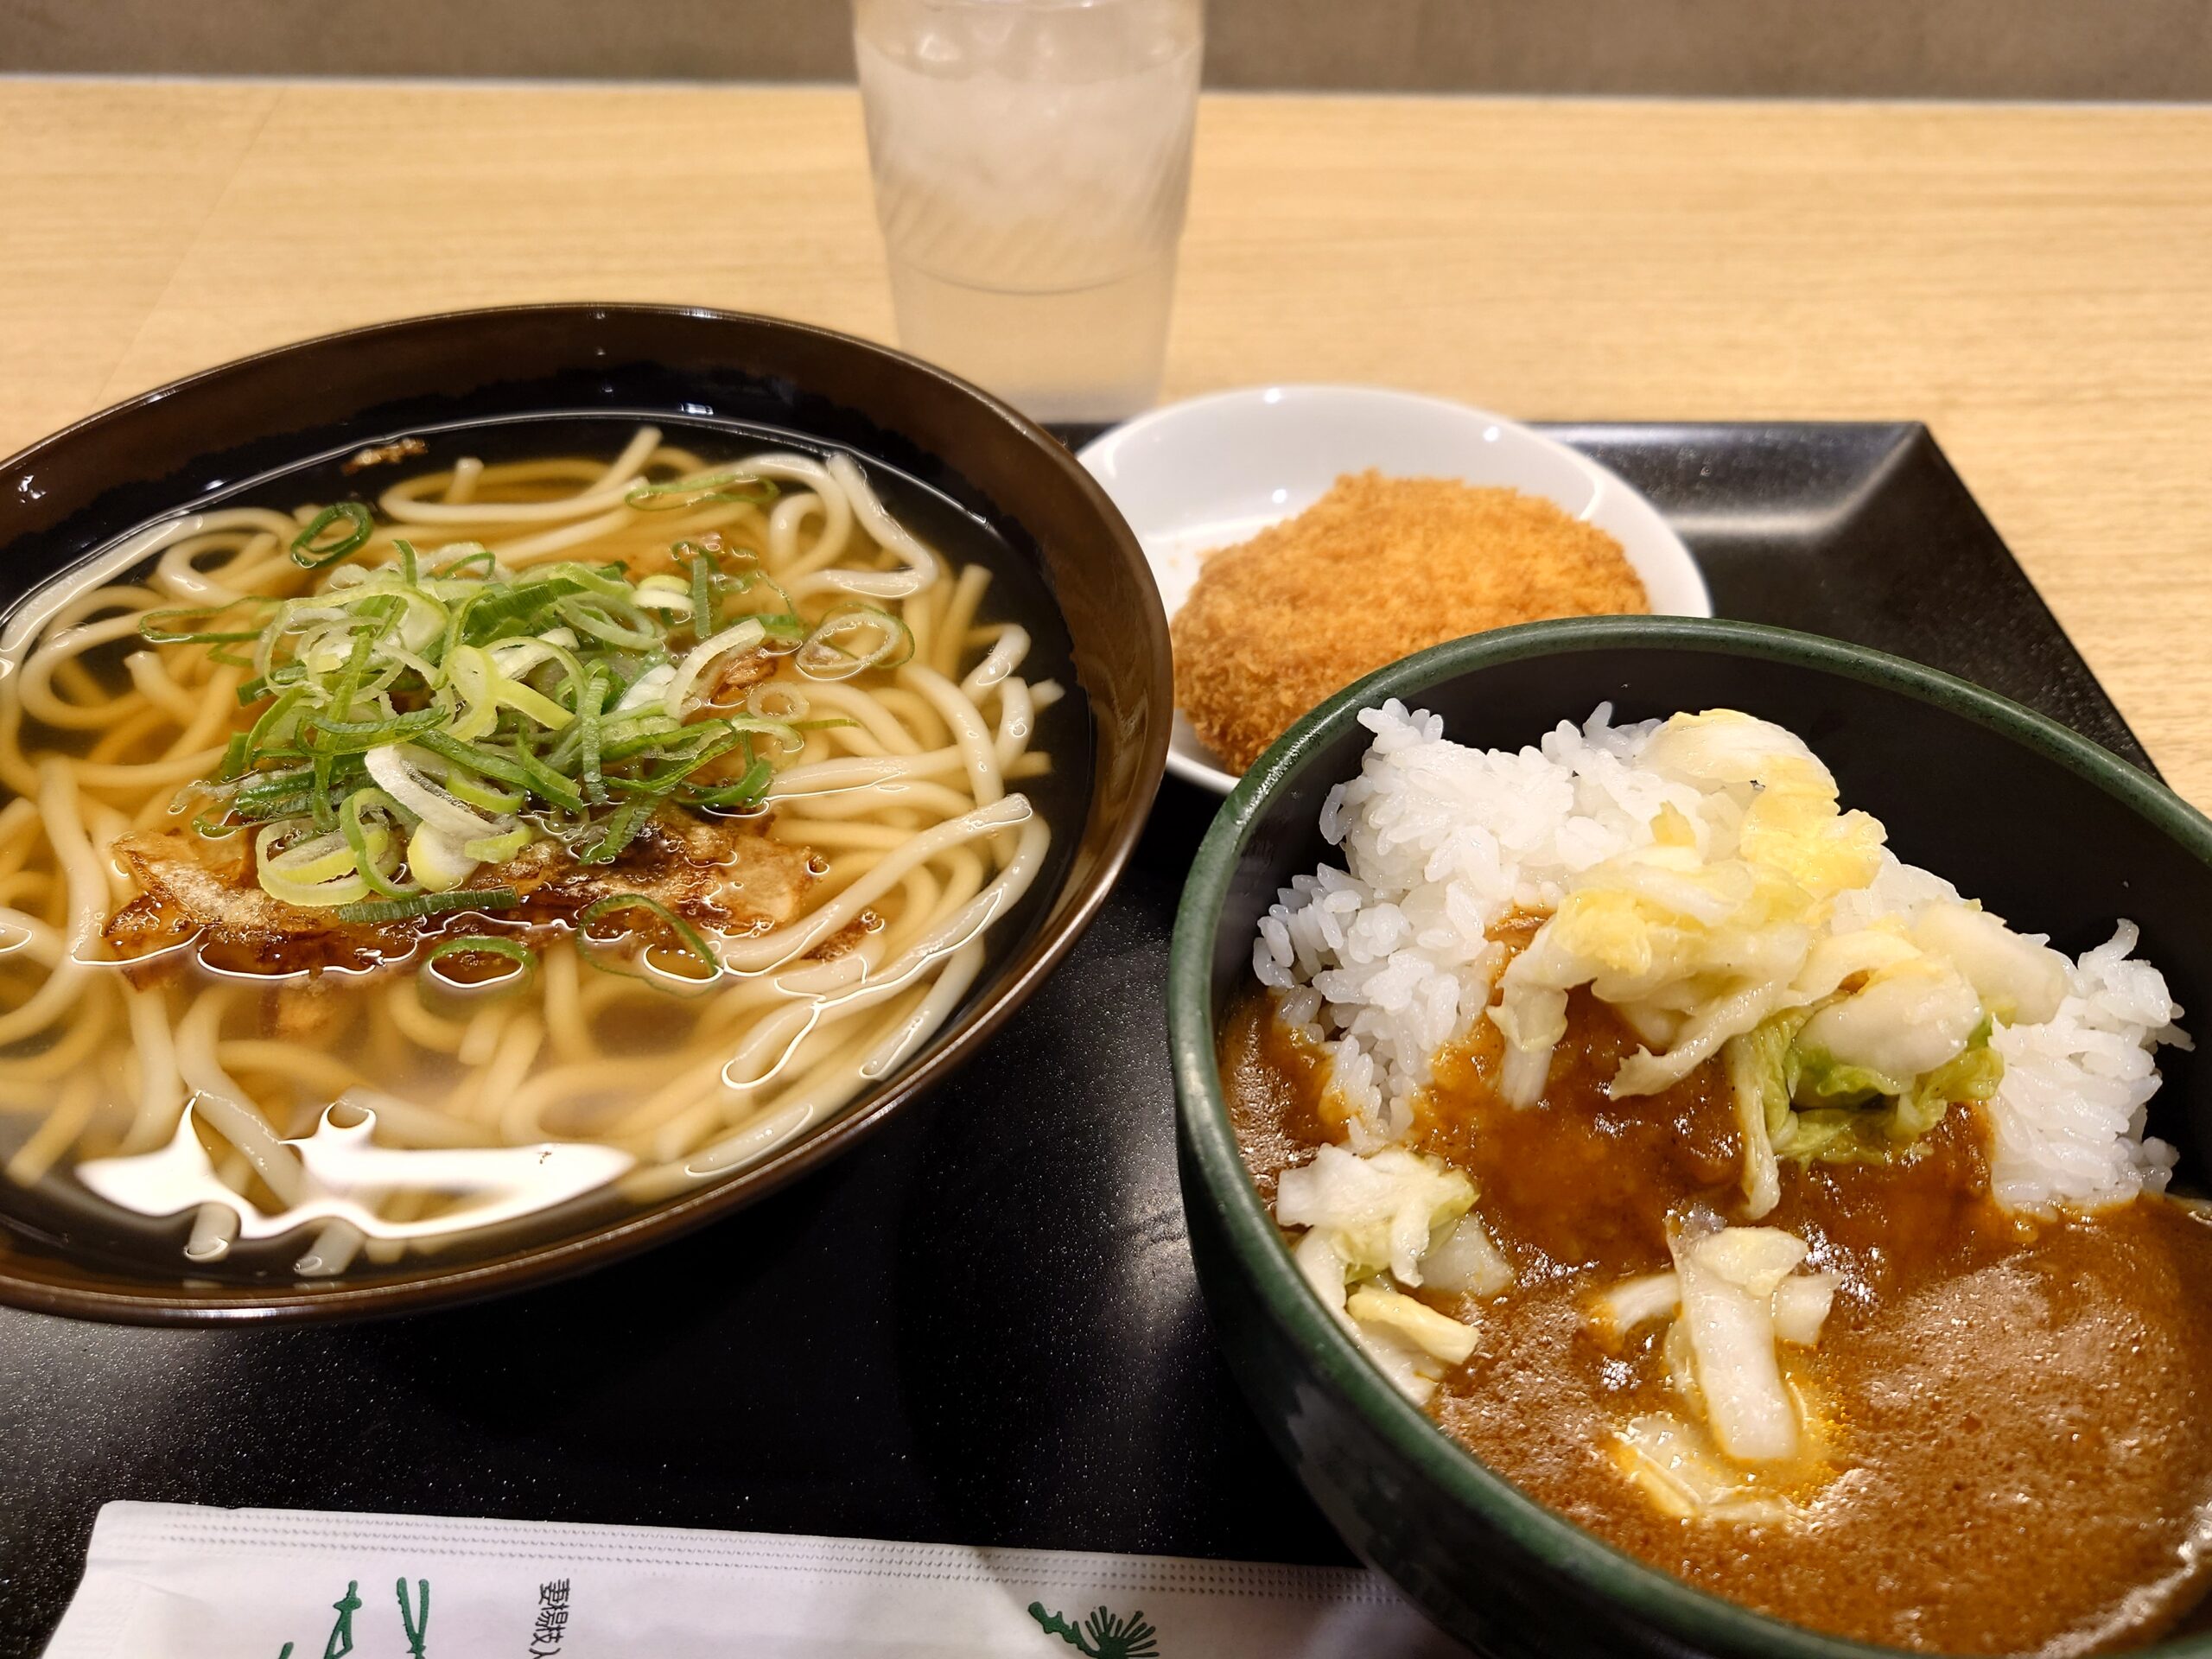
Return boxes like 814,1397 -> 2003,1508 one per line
854,0 -> 1204,420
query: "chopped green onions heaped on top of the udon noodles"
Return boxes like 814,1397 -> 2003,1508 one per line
137,506 -> 862,898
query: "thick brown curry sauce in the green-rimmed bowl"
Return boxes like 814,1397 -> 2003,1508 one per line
1221,988 -> 2212,1652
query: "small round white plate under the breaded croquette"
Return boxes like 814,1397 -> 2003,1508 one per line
1077,385 -> 1712,794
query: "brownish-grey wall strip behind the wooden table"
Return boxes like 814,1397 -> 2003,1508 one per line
0,0 -> 2212,99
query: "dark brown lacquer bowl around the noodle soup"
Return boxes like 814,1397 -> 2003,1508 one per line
0,305 -> 1173,1323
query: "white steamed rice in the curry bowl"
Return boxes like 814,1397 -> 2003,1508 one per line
1252,702 -> 2188,1210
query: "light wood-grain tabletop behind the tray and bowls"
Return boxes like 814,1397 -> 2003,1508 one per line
13,79 -> 2212,807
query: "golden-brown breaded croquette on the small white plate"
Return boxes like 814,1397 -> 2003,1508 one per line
1173,471 -> 1650,772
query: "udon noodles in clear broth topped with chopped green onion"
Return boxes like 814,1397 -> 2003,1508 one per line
0,423 -> 1086,1276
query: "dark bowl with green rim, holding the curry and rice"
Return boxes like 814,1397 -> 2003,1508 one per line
1168,617 -> 2212,1659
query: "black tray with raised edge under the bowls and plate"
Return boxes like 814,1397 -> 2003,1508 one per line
0,425 -> 2150,1659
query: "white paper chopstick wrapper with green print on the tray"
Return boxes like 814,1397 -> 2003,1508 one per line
47,1504 -> 1462,1659
